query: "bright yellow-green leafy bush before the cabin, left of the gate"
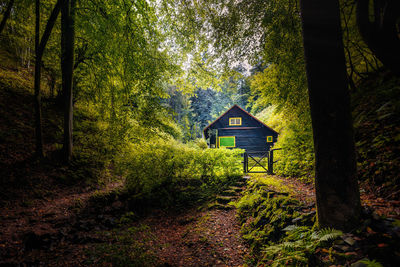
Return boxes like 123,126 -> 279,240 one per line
116,139 -> 243,205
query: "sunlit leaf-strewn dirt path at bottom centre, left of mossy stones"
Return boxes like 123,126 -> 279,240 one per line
142,209 -> 248,266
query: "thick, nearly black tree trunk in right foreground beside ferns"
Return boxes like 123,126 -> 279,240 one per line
301,0 -> 361,230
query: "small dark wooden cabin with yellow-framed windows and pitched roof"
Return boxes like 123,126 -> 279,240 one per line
203,105 -> 278,152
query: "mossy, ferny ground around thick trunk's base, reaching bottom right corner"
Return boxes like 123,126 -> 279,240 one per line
234,175 -> 400,266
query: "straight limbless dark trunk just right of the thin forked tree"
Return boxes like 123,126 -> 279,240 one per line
61,0 -> 76,163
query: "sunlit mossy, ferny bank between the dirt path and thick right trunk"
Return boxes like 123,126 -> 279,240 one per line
234,177 -> 342,266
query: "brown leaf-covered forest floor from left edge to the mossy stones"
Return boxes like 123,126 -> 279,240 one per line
0,177 -> 247,266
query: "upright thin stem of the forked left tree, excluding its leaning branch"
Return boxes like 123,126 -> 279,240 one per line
34,0 -> 44,158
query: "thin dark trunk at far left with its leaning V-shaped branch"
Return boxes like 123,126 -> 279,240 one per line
34,0 -> 62,158
